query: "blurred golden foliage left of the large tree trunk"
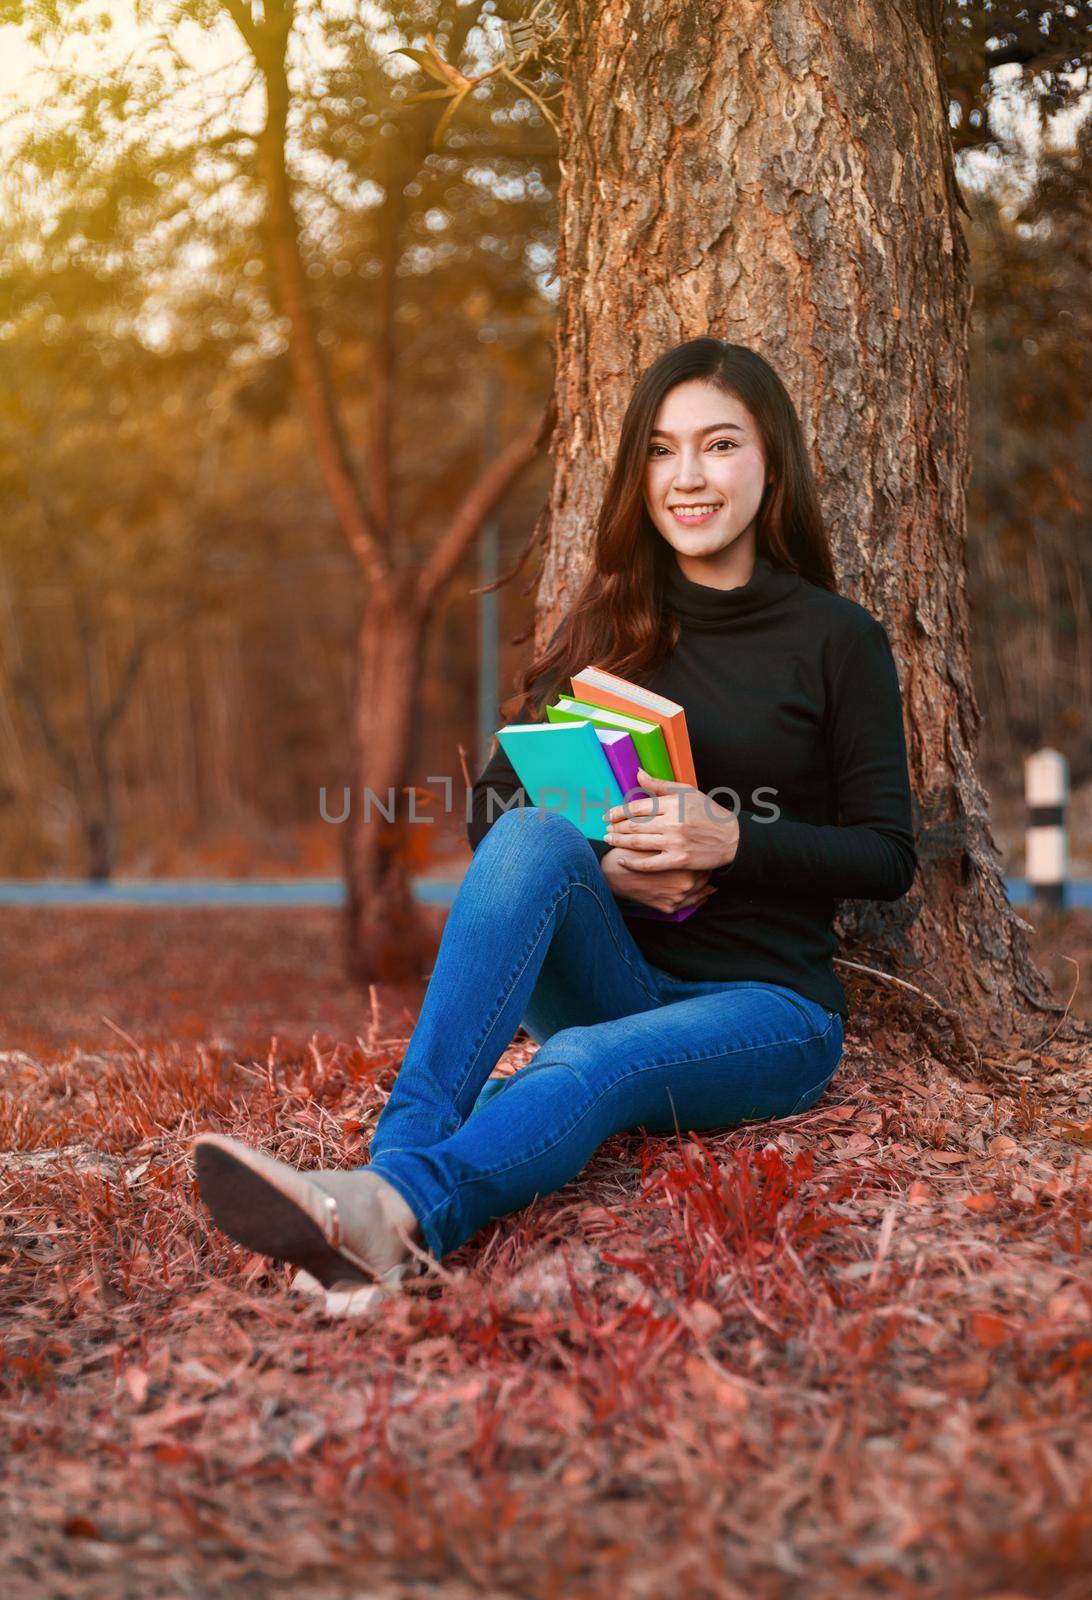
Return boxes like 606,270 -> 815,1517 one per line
0,3 -> 557,872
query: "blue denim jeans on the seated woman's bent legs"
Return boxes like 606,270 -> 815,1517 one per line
368,806 -> 842,1259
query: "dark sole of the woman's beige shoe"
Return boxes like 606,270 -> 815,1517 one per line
194,1141 -> 379,1290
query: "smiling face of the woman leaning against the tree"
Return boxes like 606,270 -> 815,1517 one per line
645,378 -> 765,589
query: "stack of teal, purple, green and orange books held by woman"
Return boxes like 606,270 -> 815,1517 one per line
496,667 -> 698,922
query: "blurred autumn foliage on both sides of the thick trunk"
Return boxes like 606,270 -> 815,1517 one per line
0,0 -> 1089,874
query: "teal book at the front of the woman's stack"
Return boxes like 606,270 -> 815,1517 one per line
496,718 -> 624,838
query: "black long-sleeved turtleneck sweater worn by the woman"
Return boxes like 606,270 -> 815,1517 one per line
468,555 -> 917,1018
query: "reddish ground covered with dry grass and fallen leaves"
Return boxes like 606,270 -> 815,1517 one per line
0,912 -> 1092,1600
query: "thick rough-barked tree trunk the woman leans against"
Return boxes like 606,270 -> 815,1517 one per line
538,0 -> 1062,1043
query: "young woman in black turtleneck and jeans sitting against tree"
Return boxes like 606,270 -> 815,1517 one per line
195,338 -> 917,1286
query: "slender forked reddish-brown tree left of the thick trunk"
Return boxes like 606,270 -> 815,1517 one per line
212,0 -> 557,981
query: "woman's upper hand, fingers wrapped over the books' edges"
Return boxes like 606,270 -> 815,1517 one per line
604,766 -> 740,874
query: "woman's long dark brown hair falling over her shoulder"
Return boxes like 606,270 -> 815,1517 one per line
501,336 -> 837,722
